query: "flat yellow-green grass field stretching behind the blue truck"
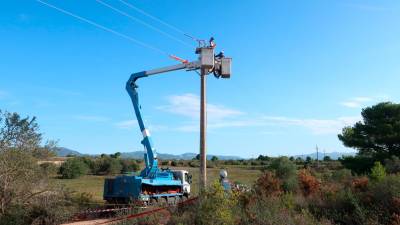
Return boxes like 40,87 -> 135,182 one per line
55,167 -> 261,201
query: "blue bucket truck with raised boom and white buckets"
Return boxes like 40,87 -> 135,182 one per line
103,40 -> 231,205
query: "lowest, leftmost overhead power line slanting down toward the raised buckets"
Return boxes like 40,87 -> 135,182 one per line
36,0 -> 170,56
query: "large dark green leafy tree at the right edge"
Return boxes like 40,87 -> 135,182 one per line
338,102 -> 400,159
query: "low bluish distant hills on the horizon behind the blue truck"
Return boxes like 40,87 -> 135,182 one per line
55,147 -> 242,160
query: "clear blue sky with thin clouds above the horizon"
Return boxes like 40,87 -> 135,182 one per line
0,0 -> 400,158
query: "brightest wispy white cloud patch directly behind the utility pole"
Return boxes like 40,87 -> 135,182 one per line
157,93 -> 243,121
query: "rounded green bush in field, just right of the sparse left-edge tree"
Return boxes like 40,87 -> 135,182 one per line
59,158 -> 88,179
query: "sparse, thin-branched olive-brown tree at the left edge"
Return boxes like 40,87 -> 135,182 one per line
0,112 -> 75,224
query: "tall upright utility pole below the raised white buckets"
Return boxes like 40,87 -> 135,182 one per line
200,69 -> 207,189
